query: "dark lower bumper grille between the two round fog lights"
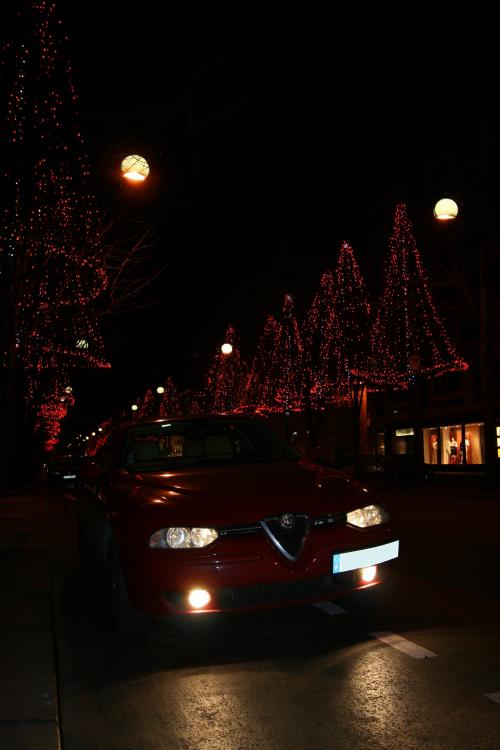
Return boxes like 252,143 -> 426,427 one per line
216,572 -> 355,609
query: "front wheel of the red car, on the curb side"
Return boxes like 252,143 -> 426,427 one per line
106,545 -> 149,638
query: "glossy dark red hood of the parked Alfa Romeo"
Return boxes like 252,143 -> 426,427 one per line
120,461 -> 374,526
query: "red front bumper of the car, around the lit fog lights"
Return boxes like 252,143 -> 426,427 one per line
121,534 -> 397,616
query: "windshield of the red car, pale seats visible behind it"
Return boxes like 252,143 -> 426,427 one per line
124,418 -> 301,472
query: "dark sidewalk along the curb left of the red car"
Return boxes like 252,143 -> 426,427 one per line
0,485 -> 61,750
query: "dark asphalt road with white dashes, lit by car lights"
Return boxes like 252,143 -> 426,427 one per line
52,487 -> 500,750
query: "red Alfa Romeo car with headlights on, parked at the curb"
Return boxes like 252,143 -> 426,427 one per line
78,415 -> 399,633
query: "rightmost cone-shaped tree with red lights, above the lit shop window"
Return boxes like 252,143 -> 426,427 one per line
359,203 -> 467,390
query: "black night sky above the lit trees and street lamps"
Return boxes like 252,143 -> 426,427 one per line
49,0 -> 499,434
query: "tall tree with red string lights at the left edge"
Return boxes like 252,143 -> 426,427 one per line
0,0 -> 108,482
